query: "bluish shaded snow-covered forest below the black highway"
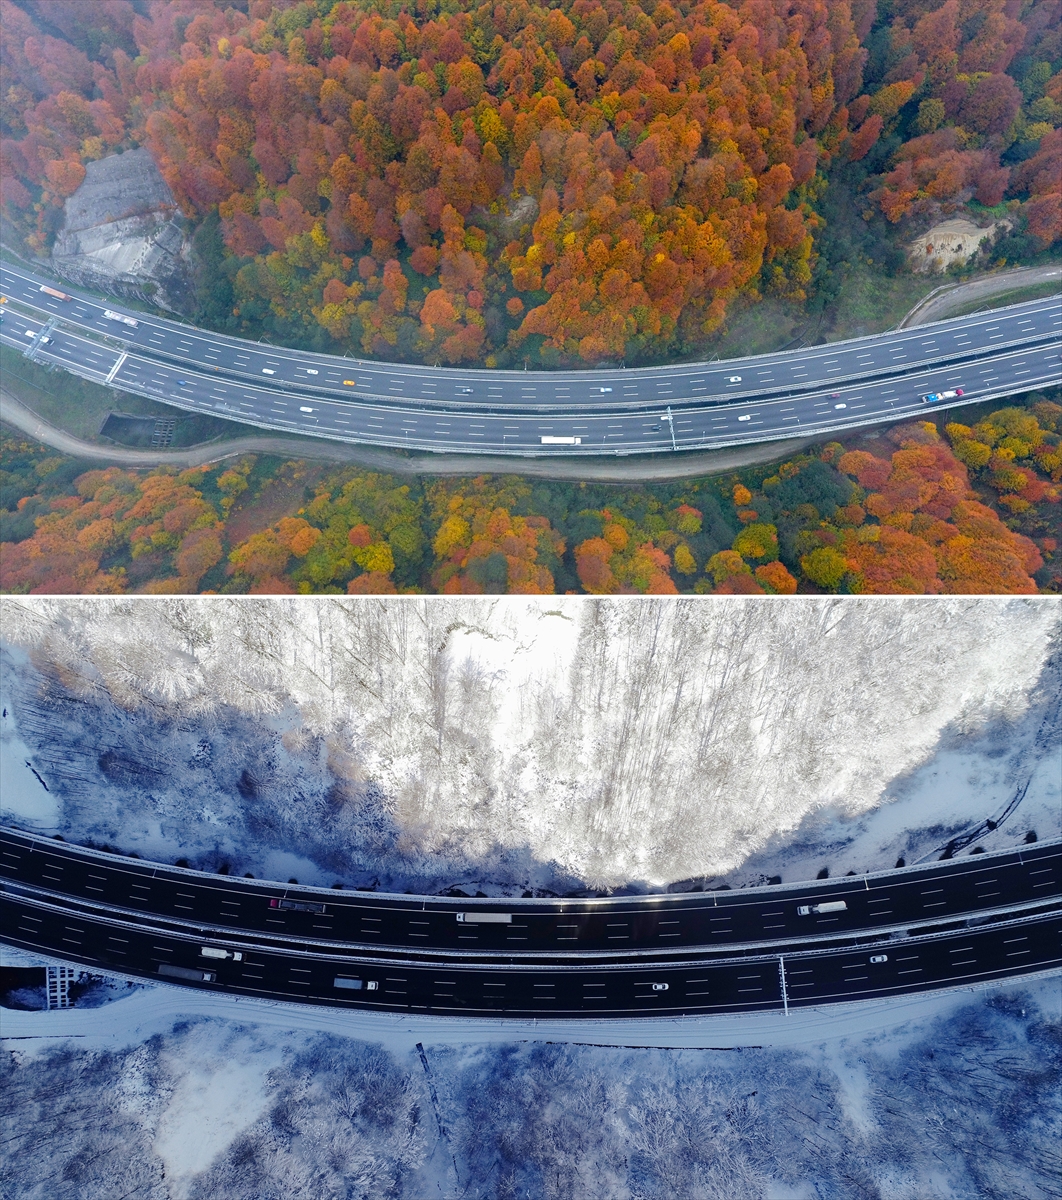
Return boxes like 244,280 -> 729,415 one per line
0,979 -> 1062,1200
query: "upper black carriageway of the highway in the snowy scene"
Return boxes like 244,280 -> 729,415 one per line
0,829 -> 1062,961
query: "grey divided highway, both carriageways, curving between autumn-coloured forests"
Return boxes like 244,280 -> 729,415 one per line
0,263 -> 1062,455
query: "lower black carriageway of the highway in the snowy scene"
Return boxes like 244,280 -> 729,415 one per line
0,893 -> 1062,1018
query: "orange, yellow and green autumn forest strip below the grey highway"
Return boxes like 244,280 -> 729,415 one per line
0,395 -> 1062,595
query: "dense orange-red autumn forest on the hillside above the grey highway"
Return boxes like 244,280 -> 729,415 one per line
0,0 -> 1062,366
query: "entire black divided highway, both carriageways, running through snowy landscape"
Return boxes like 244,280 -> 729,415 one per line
0,830 -> 1062,1016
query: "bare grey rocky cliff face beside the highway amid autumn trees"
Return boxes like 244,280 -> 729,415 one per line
52,149 -> 193,312
